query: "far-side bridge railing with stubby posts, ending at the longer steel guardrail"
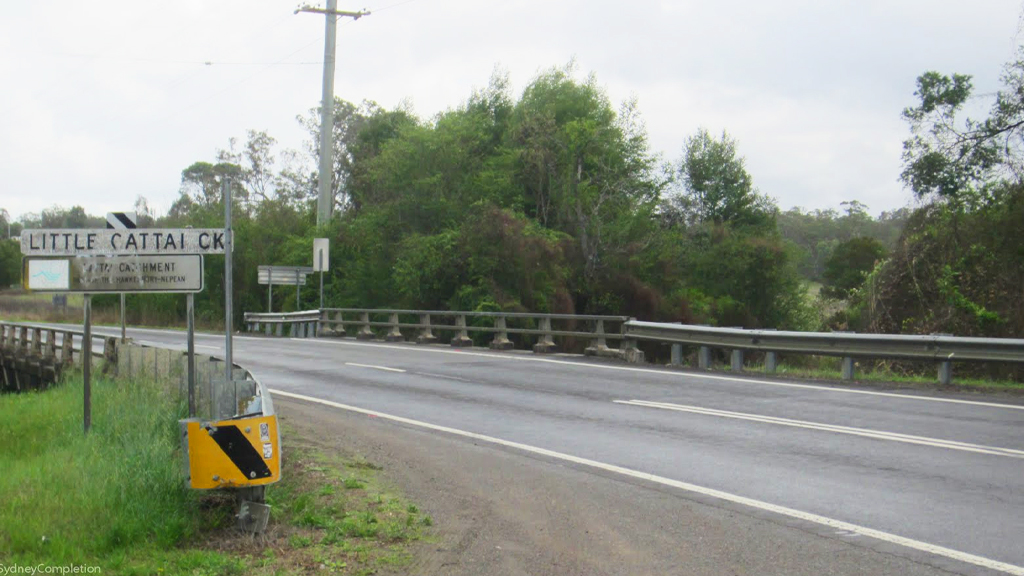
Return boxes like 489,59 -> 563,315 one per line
245,308 -> 642,362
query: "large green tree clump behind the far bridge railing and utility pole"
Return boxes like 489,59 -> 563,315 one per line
8,65 -> 827,328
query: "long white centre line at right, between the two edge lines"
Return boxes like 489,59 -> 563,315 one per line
612,400 -> 1024,458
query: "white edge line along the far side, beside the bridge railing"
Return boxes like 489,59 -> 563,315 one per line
288,336 -> 1024,410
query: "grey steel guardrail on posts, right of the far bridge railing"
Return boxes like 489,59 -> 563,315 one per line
623,320 -> 1024,384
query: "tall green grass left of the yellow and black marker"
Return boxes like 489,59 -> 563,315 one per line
0,368 -> 199,564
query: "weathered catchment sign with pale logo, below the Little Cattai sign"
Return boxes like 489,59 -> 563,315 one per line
23,254 -> 203,293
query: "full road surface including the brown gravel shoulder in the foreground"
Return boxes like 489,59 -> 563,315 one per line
75,328 -> 1024,574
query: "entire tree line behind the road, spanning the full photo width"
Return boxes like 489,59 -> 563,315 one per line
0,56 -> 1024,350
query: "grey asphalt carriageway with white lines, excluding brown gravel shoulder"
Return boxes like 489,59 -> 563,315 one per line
72,328 -> 1024,574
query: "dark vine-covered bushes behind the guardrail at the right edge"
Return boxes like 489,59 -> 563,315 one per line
864,186 -> 1024,337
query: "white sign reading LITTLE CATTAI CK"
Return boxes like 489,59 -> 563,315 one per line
22,228 -> 231,256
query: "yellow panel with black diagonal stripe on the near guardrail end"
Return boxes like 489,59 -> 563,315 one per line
181,415 -> 281,490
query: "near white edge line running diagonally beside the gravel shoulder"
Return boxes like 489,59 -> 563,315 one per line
270,389 -> 1024,576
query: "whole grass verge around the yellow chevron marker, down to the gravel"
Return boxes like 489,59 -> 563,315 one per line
0,368 -> 432,576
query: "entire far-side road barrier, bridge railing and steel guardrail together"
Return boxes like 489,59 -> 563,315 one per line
237,308 -> 1024,384
